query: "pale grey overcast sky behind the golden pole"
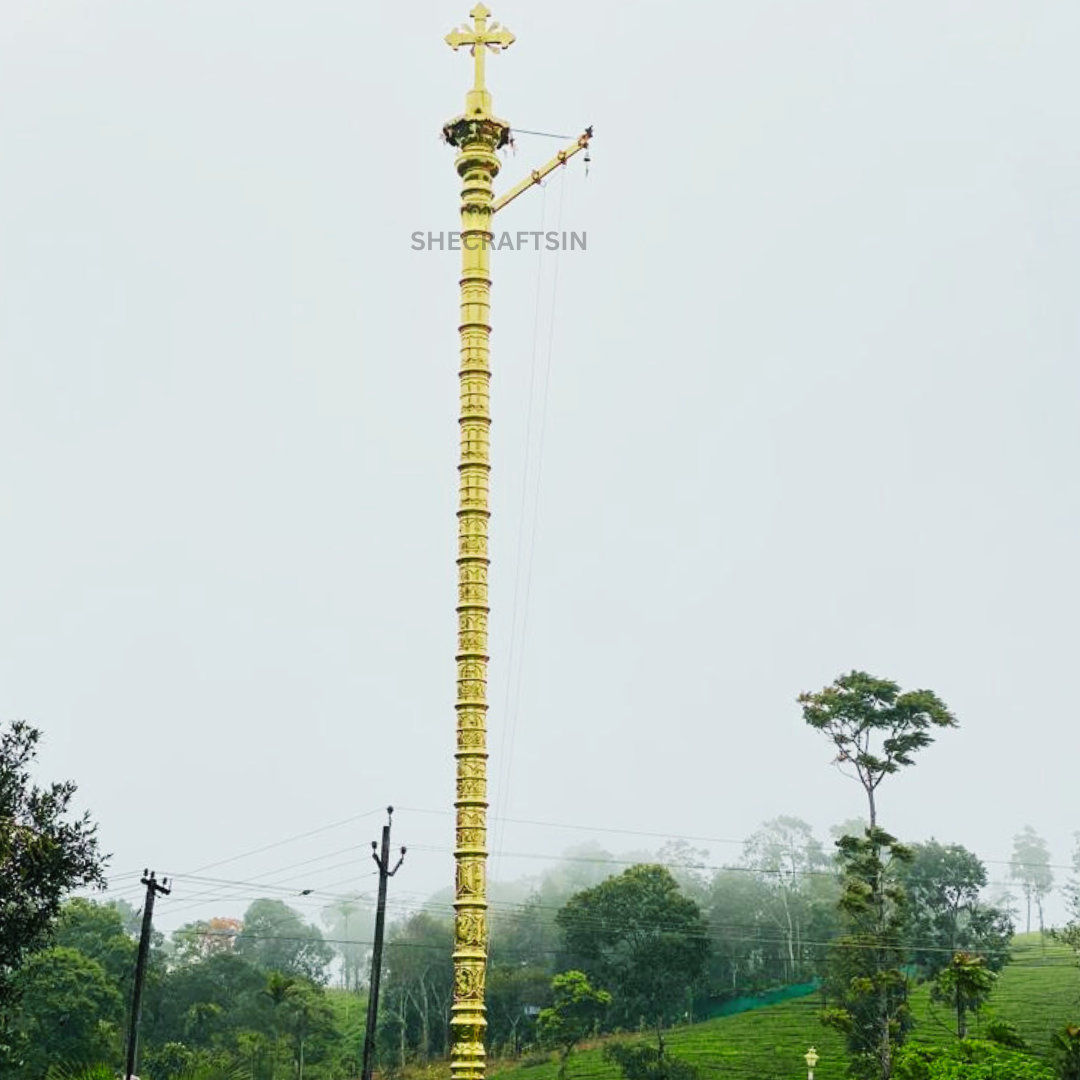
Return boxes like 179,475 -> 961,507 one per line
0,0 -> 1080,929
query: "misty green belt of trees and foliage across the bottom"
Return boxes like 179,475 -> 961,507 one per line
8,699 -> 1080,1080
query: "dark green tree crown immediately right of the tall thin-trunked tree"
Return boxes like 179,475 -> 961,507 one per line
901,839 -> 1013,978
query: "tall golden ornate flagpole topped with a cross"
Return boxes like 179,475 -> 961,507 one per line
442,3 -> 593,1080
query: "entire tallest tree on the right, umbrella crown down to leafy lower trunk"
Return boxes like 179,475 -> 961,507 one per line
798,672 -> 957,1080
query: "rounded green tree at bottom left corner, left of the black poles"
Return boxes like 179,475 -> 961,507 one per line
6,947 -> 123,1080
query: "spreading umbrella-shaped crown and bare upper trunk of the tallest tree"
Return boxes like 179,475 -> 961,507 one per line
798,672 -> 958,828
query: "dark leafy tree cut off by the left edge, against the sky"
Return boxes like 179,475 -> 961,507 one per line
0,720 -> 106,1010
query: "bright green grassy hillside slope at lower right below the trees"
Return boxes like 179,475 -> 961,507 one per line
490,934 -> 1080,1080
